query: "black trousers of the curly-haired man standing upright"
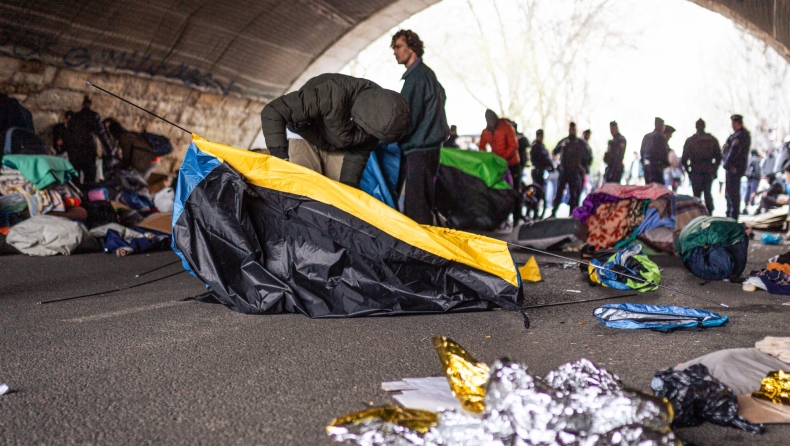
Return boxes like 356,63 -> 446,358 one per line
400,147 -> 441,225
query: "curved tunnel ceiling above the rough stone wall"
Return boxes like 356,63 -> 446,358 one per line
0,0 -> 790,100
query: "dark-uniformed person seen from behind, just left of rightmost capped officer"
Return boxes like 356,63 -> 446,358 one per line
680,118 -> 721,215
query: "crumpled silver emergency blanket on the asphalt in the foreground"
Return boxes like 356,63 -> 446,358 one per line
327,359 -> 681,446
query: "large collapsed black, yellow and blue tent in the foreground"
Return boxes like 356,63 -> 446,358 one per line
172,136 -> 522,317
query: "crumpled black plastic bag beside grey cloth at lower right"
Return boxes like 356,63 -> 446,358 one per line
650,364 -> 765,434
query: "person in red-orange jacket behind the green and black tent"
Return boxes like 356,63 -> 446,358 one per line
480,110 -> 522,227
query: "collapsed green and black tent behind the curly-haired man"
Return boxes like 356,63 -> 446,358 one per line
435,148 -> 520,231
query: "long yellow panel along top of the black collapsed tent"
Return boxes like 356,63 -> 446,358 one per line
192,135 -> 518,286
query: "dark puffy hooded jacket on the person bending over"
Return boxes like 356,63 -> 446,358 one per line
261,74 -> 409,152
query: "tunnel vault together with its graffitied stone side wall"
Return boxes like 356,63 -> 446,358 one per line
0,0 -> 790,168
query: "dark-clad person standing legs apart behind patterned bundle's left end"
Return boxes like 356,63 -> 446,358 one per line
551,122 -> 590,218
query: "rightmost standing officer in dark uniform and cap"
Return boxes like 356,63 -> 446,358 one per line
722,115 -> 752,220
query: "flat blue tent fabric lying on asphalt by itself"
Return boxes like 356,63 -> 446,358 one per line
593,303 -> 729,331
